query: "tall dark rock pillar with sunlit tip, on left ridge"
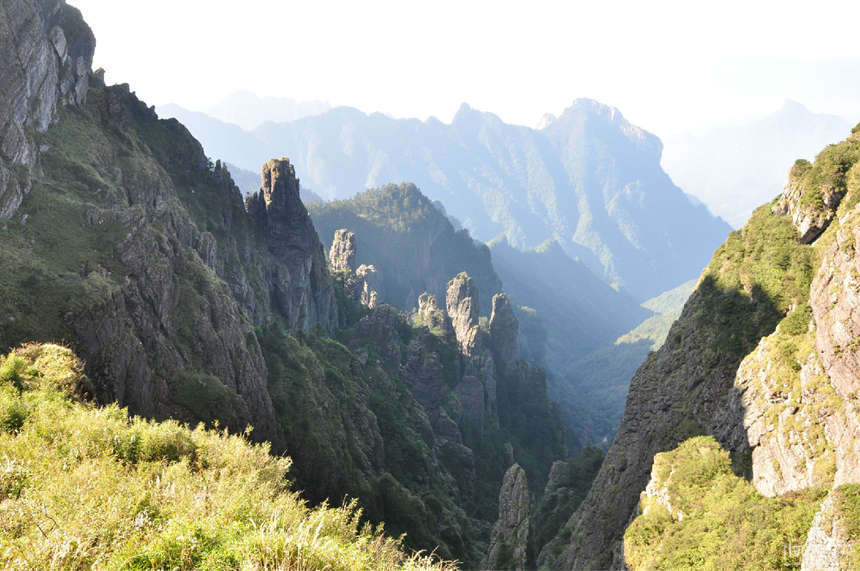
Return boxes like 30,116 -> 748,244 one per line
248,158 -> 337,333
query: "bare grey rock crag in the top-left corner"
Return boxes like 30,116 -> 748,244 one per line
0,0 -> 96,220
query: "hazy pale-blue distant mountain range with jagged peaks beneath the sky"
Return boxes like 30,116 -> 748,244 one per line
158,99 -> 730,301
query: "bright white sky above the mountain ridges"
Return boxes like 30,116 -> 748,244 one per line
69,0 -> 860,136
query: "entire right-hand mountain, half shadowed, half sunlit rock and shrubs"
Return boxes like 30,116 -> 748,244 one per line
553,123 -> 860,569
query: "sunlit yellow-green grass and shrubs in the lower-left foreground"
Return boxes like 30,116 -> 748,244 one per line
0,345 -> 451,571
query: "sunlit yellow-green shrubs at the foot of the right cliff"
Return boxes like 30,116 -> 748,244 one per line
624,436 -> 826,570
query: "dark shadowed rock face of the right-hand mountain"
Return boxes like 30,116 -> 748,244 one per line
555,281 -> 764,569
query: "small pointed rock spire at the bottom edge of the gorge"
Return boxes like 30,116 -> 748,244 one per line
481,464 -> 533,571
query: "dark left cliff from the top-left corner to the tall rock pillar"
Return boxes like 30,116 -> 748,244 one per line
0,1 -> 337,450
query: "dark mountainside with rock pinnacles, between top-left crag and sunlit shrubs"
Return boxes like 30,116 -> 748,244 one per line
0,4 -> 566,567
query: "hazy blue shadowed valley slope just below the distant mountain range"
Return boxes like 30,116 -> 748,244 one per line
489,237 -> 652,450
